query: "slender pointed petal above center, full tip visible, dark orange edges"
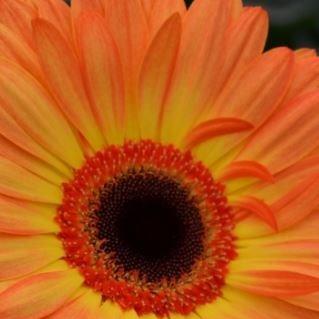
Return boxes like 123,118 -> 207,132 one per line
138,12 -> 181,139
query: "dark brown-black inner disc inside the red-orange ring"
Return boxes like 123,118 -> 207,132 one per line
94,168 -> 204,282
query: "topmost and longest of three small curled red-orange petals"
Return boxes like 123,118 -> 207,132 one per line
184,118 -> 253,149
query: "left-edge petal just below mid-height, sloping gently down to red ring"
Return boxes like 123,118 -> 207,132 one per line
0,156 -> 62,204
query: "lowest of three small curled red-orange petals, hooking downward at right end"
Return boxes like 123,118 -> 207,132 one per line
231,196 -> 278,230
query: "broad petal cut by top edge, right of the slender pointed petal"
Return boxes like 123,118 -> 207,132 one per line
162,0 -> 231,143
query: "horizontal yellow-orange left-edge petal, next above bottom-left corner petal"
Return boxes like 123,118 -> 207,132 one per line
0,235 -> 64,280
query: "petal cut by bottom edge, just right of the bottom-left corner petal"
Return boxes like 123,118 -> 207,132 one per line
48,290 -> 101,319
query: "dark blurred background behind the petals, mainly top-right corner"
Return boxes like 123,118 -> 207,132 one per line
65,0 -> 319,50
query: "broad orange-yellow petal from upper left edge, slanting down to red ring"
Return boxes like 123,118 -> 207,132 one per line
0,59 -> 83,167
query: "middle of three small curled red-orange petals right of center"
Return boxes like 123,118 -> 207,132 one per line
219,161 -> 274,182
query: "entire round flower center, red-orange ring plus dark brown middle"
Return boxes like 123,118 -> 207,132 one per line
57,141 -> 235,316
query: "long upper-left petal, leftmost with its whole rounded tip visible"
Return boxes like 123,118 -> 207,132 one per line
33,19 -> 104,149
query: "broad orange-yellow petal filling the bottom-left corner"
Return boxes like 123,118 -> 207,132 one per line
0,270 -> 82,319
